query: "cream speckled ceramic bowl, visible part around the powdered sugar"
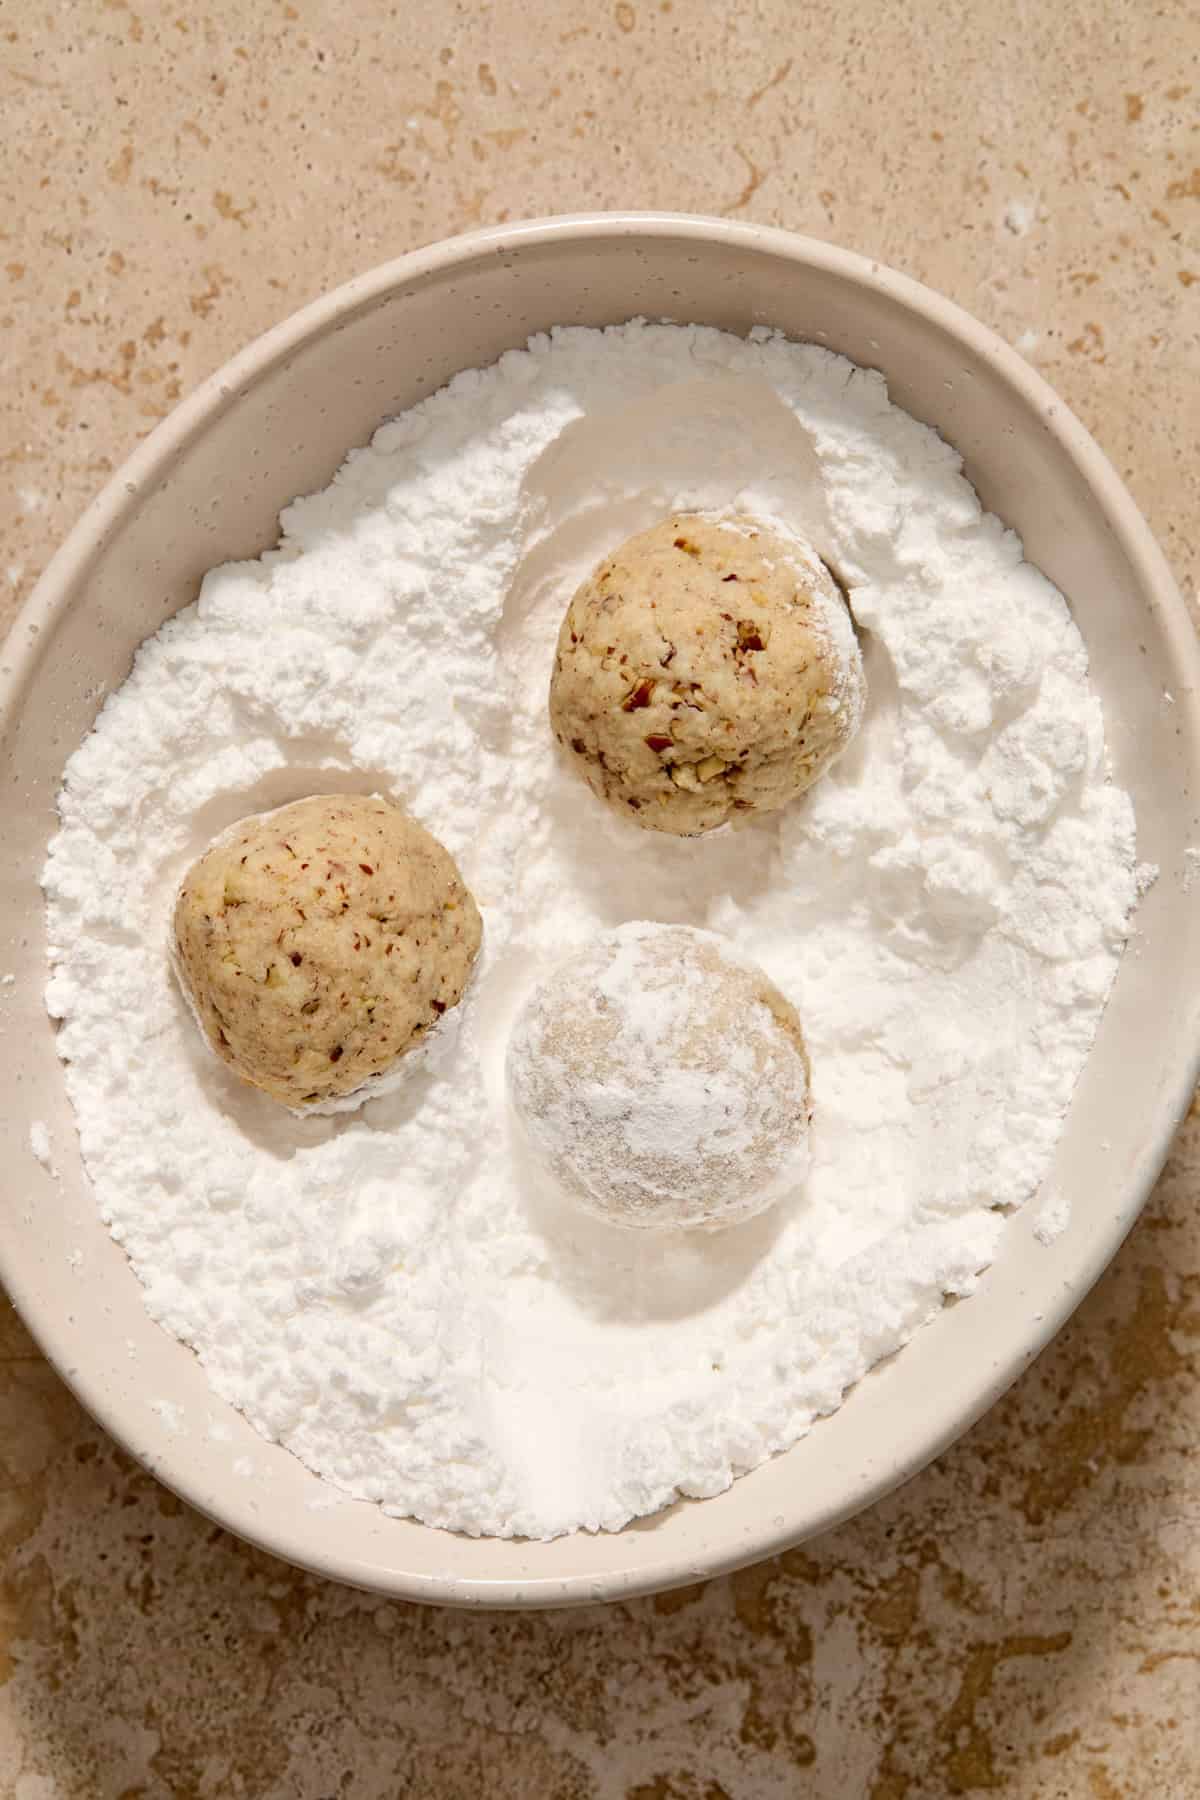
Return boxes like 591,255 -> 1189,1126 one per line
0,214 -> 1200,1606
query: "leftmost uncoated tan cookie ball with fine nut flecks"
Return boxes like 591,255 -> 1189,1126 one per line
175,794 -> 480,1111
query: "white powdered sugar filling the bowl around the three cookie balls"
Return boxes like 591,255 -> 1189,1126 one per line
45,324 -> 1135,1535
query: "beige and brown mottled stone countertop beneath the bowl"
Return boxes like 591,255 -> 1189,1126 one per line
0,0 -> 1200,1800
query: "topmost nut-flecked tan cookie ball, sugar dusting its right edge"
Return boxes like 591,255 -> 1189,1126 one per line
551,513 -> 865,837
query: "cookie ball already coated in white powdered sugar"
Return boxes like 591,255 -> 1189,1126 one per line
507,923 -> 810,1231
